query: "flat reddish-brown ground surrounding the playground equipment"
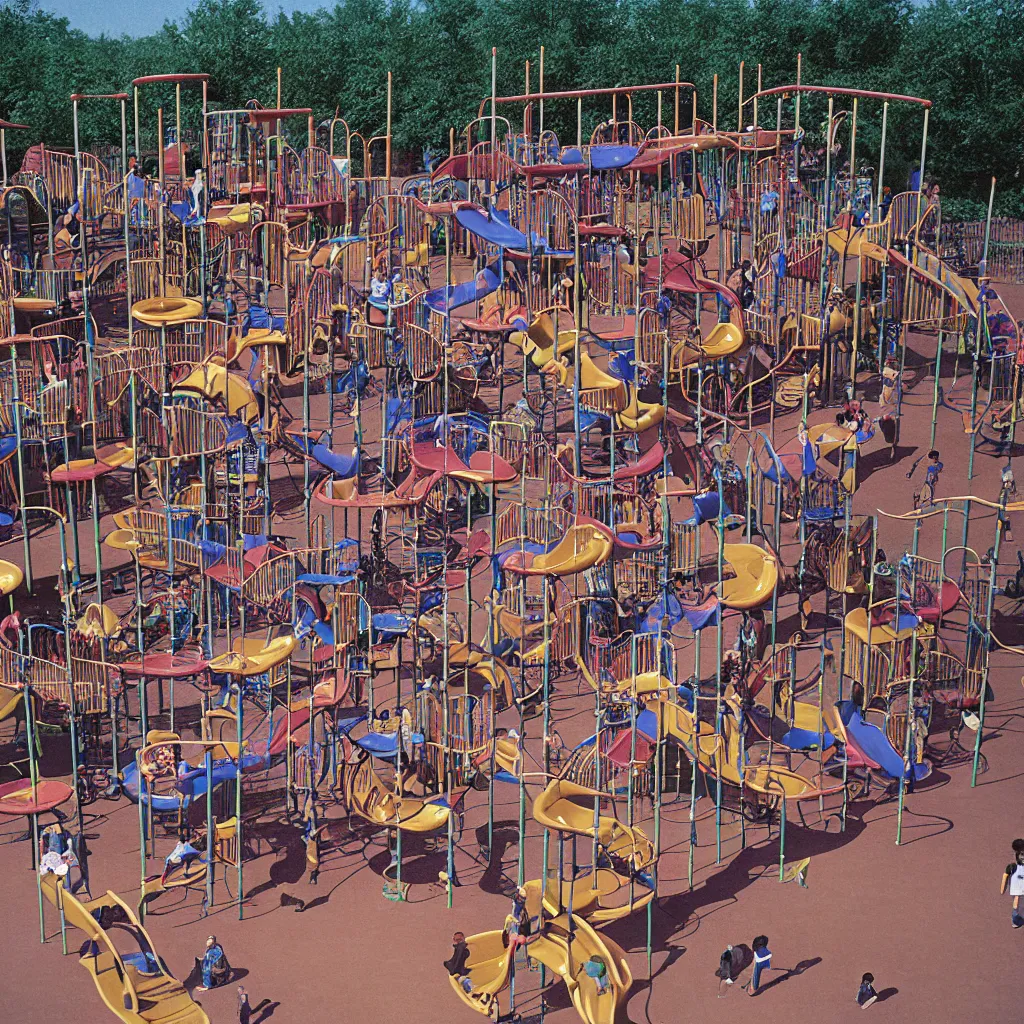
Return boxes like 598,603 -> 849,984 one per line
0,272 -> 1024,1024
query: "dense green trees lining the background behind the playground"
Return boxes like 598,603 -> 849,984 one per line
0,0 -> 1024,213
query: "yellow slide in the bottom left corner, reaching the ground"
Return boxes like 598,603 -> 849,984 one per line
40,873 -> 210,1024
